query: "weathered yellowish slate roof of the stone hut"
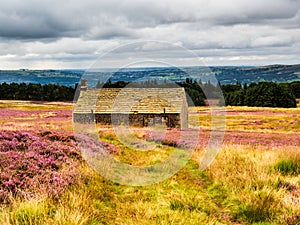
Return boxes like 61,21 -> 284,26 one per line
74,88 -> 186,114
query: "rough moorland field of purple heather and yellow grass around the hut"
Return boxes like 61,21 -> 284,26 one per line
0,101 -> 300,225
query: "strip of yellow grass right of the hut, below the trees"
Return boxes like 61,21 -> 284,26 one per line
189,106 -> 300,133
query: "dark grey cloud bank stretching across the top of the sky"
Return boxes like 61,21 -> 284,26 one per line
0,0 -> 299,39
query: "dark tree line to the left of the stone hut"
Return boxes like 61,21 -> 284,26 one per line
0,82 -> 75,101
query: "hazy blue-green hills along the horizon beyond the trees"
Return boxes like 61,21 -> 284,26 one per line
0,64 -> 300,86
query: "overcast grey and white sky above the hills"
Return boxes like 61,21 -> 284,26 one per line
0,0 -> 300,69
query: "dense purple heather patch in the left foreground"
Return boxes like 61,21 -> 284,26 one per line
0,130 -> 81,203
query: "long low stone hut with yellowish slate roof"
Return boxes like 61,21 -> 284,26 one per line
73,83 -> 188,128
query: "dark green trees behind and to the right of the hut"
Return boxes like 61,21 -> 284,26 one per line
100,78 -> 300,108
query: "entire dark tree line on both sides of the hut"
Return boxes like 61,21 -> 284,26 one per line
0,78 -> 300,108
